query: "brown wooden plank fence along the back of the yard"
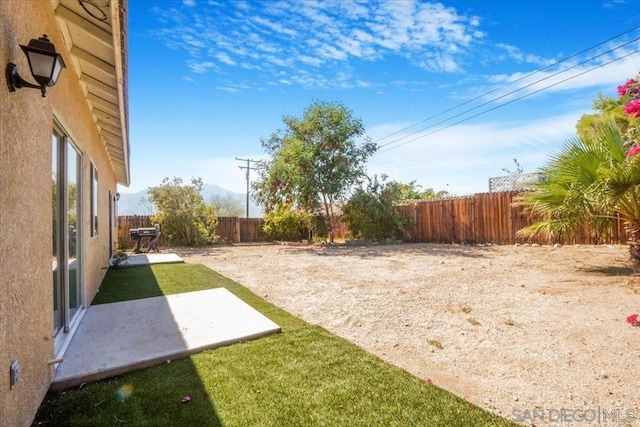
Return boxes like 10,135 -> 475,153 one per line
118,192 -> 626,248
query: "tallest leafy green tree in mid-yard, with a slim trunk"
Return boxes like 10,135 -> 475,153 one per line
253,102 -> 377,242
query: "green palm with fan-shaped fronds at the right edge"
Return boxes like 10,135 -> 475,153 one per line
516,121 -> 640,260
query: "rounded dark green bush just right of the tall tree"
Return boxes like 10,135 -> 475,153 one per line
344,175 -> 409,241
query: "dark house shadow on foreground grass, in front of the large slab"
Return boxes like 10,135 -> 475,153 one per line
33,358 -> 222,427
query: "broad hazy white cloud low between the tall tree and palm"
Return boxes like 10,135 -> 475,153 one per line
367,111 -> 583,195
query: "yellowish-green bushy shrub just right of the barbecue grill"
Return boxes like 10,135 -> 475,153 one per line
149,178 -> 218,246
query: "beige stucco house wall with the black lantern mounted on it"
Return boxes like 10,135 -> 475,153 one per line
0,0 -> 116,426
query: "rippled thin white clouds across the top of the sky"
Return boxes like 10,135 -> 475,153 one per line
151,0 -> 482,87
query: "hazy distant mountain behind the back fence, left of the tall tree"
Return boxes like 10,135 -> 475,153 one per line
118,184 -> 262,218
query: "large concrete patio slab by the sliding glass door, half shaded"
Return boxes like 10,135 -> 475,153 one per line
51,254 -> 280,390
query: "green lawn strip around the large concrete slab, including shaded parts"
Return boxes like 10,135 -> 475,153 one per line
35,264 -> 513,426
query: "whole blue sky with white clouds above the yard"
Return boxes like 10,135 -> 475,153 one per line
120,0 -> 640,195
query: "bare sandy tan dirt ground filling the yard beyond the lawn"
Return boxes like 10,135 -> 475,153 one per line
175,244 -> 640,425
